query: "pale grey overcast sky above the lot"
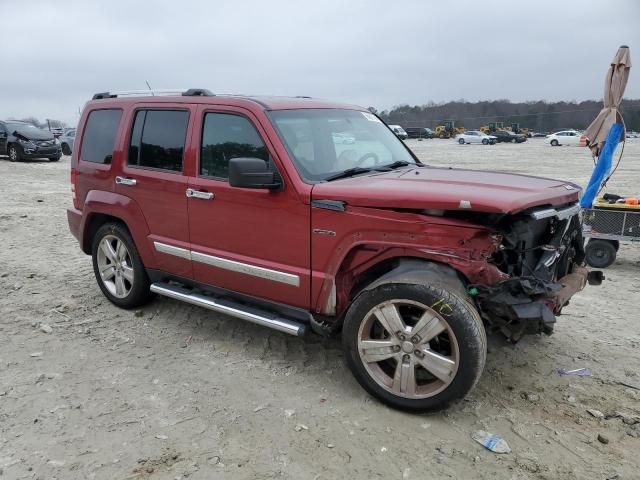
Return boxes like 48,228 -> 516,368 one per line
0,0 -> 640,124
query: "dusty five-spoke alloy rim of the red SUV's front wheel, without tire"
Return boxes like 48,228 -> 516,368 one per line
358,300 -> 460,399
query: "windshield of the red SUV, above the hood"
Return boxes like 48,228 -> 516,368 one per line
269,109 -> 416,182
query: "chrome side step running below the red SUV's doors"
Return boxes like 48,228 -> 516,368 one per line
151,283 -> 305,337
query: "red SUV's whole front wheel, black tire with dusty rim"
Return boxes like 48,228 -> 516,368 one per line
342,283 -> 487,412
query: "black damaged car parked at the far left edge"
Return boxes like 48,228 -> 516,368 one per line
0,120 -> 62,162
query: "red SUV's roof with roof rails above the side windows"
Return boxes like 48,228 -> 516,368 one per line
89,92 -> 366,111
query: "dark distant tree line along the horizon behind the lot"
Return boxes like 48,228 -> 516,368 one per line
370,99 -> 640,132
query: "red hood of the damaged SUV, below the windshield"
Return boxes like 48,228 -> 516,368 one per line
312,167 -> 580,213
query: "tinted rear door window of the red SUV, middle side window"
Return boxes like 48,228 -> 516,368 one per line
128,110 -> 189,172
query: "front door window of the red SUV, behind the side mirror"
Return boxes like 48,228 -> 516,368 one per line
199,113 -> 269,178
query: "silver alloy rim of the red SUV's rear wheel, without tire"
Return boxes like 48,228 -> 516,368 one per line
97,235 -> 134,298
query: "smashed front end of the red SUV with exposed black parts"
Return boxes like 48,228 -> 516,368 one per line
469,204 -> 602,342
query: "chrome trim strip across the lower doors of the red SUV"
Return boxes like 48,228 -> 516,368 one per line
153,241 -> 300,287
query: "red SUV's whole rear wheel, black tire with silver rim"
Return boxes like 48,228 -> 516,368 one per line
91,223 -> 153,309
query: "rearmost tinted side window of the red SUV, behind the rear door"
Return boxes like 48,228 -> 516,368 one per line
80,109 -> 122,163
